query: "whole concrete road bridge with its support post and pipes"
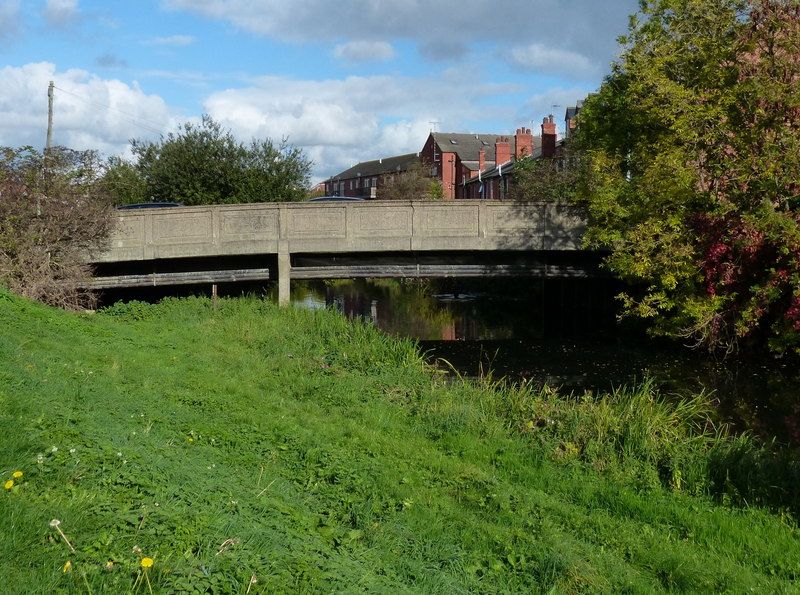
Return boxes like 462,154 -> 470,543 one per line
93,200 -> 599,303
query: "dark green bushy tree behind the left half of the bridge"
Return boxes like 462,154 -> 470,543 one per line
131,115 -> 311,205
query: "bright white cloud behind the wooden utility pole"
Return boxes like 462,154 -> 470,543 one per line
0,62 -> 176,155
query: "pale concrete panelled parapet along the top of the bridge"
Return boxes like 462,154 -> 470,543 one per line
93,200 -> 584,263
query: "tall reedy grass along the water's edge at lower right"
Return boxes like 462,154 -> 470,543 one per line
440,379 -> 800,518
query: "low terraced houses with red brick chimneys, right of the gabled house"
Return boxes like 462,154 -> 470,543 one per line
461,115 -> 563,200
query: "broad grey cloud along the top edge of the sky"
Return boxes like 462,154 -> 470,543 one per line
162,0 -> 638,77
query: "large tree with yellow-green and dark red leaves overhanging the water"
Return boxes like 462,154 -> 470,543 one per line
578,0 -> 800,351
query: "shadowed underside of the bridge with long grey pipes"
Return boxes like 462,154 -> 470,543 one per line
91,251 -> 606,289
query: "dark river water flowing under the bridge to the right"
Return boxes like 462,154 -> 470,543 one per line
292,279 -> 800,445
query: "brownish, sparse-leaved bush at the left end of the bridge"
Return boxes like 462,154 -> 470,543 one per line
0,147 -> 113,309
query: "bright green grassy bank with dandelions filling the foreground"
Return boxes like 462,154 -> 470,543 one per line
0,292 -> 800,593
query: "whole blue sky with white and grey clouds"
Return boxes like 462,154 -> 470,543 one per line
0,0 -> 637,181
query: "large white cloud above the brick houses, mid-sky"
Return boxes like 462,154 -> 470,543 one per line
204,76 -> 515,179
